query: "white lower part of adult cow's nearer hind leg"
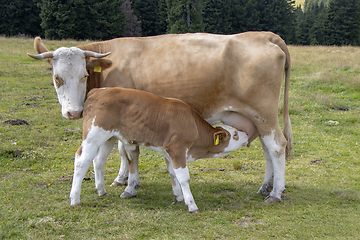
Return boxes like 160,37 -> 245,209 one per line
262,131 -> 285,201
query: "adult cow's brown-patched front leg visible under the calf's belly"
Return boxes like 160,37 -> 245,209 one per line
120,145 -> 140,198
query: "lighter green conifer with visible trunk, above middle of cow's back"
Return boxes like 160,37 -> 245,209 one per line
166,0 -> 205,33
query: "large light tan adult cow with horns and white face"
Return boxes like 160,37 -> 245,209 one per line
29,32 -> 293,203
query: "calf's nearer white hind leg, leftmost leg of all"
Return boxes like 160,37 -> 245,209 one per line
70,142 -> 98,206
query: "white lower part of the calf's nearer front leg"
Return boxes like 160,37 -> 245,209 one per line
174,167 -> 199,213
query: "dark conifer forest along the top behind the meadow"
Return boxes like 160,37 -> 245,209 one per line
0,0 -> 360,46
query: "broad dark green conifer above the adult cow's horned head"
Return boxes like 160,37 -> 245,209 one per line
40,0 -> 124,40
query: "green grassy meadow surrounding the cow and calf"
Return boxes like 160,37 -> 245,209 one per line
0,37 -> 360,239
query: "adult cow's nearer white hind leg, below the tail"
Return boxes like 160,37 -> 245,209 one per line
261,128 -> 286,203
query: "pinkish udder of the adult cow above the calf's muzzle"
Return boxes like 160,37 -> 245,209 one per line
221,112 -> 259,147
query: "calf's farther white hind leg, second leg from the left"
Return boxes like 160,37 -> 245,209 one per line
93,138 -> 116,196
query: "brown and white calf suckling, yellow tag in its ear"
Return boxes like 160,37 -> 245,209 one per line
70,88 -> 248,212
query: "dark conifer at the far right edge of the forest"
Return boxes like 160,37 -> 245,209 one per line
326,0 -> 360,45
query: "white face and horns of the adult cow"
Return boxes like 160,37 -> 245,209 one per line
28,42 -> 110,119
